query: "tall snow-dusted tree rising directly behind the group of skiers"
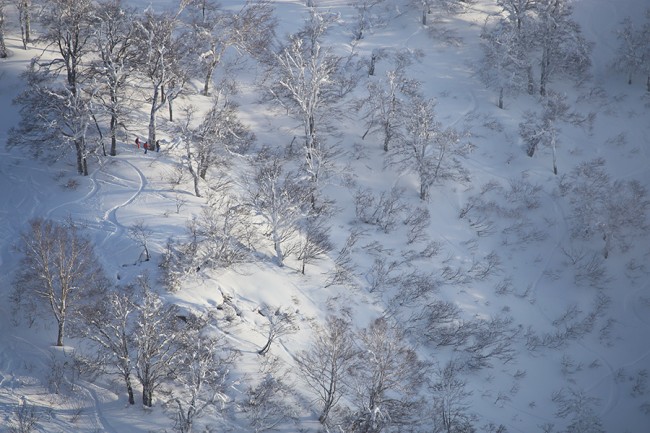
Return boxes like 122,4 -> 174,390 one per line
134,9 -> 189,144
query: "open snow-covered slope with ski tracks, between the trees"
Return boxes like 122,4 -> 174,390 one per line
0,0 -> 650,433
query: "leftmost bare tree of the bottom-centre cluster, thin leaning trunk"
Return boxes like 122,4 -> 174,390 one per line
296,316 -> 358,424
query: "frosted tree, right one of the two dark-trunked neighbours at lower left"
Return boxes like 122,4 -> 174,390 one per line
132,275 -> 182,407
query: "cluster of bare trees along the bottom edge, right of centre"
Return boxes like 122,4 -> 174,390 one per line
296,316 -> 476,433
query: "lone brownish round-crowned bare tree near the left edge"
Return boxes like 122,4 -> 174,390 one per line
14,218 -> 108,346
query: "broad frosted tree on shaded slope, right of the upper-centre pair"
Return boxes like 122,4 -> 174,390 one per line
389,96 -> 467,200
